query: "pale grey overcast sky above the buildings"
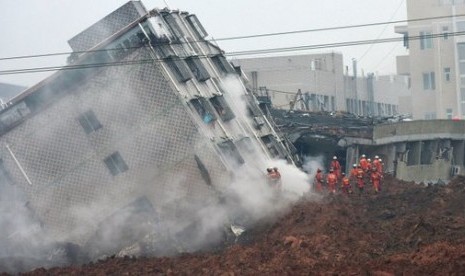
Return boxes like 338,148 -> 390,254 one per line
0,0 -> 406,86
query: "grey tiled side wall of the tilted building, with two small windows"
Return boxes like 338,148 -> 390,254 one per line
0,50 -> 228,242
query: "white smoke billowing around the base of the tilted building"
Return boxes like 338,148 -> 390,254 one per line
0,67 -> 314,272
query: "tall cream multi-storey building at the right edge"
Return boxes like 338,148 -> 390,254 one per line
396,0 -> 465,119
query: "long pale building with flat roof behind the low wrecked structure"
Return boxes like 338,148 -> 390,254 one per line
232,52 -> 409,116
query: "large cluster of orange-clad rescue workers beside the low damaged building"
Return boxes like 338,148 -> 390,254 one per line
313,154 -> 384,195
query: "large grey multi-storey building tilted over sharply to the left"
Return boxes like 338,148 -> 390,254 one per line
0,1 -> 296,264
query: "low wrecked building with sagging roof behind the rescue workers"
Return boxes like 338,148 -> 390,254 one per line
269,109 -> 465,183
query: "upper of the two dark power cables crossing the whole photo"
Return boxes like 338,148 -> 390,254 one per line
0,14 -> 465,61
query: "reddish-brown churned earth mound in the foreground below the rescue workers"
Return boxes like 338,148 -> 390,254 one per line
4,176 -> 465,276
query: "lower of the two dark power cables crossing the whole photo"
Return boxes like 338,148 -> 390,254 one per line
0,29 -> 456,75
